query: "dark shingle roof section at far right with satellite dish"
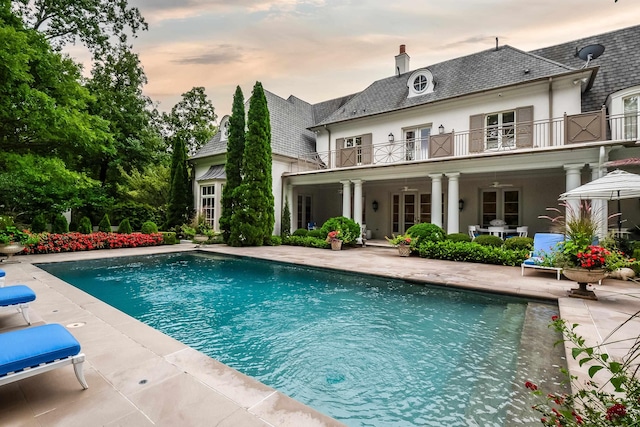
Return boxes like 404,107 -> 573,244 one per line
532,25 -> 640,111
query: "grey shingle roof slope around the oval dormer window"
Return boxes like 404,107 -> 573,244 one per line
317,46 -> 575,125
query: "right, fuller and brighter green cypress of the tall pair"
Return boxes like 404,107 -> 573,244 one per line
229,82 -> 275,246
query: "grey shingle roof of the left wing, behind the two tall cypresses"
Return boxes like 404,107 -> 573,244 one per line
191,90 -> 316,159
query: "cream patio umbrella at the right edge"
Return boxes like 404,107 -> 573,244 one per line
559,170 -> 640,231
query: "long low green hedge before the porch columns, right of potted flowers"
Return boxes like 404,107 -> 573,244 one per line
418,242 -> 529,266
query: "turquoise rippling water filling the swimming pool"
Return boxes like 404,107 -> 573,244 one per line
38,253 -> 548,426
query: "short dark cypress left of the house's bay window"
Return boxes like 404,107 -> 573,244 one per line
166,139 -> 193,228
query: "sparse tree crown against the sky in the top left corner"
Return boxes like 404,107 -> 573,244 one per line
11,0 -> 148,54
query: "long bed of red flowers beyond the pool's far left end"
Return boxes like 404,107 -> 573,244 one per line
21,232 -> 163,255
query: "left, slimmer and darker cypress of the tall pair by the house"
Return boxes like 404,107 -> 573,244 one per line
220,86 -> 245,243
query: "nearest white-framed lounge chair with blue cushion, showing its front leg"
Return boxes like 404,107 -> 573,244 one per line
0,323 -> 89,389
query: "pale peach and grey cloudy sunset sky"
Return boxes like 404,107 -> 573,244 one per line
71,0 -> 640,119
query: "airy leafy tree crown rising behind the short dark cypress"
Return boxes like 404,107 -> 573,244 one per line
164,86 -> 217,156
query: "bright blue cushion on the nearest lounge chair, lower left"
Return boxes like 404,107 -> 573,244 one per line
0,324 -> 80,376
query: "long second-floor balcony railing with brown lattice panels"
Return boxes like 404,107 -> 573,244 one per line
298,108 -> 640,170
